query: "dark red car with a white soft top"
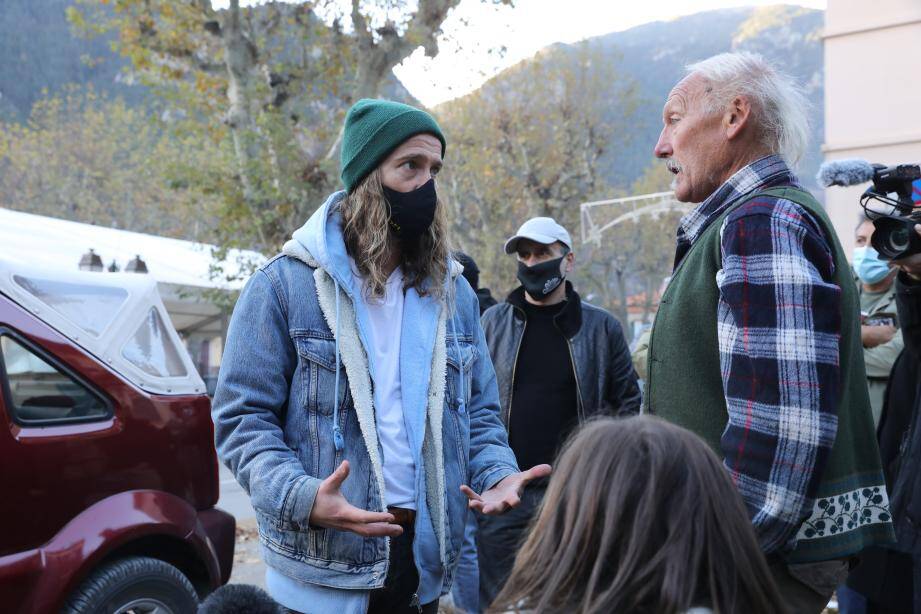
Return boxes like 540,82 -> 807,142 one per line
0,259 -> 235,614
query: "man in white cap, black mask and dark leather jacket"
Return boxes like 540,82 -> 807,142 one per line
477,217 -> 641,606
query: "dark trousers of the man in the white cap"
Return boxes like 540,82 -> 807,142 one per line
476,485 -> 547,610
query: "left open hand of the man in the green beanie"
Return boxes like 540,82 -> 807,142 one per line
310,461 -> 403,537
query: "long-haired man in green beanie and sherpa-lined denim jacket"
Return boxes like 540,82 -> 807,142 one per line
213,100 -> 550,614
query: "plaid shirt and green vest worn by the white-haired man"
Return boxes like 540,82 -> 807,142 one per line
646,156 -> 893,562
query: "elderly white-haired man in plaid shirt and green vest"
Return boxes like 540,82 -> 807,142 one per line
646,53 -> 893,612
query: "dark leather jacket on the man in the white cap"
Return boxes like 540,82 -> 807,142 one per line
481,282 -> 642,424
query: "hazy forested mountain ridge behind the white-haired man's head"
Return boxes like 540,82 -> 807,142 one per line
435,4 -> 824,189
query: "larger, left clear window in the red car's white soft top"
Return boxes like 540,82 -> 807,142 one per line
13,275 -> 128,337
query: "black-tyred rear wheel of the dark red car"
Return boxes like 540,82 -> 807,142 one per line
63,557 -> 198,614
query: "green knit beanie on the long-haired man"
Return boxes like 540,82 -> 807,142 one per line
340,98 -> 446,192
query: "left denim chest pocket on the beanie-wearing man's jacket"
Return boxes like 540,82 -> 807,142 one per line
293,331 -> 350,416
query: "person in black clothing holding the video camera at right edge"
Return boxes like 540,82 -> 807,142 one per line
847,224 -> 921,614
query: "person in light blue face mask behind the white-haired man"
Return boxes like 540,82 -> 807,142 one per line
853,219 -> 902,424
